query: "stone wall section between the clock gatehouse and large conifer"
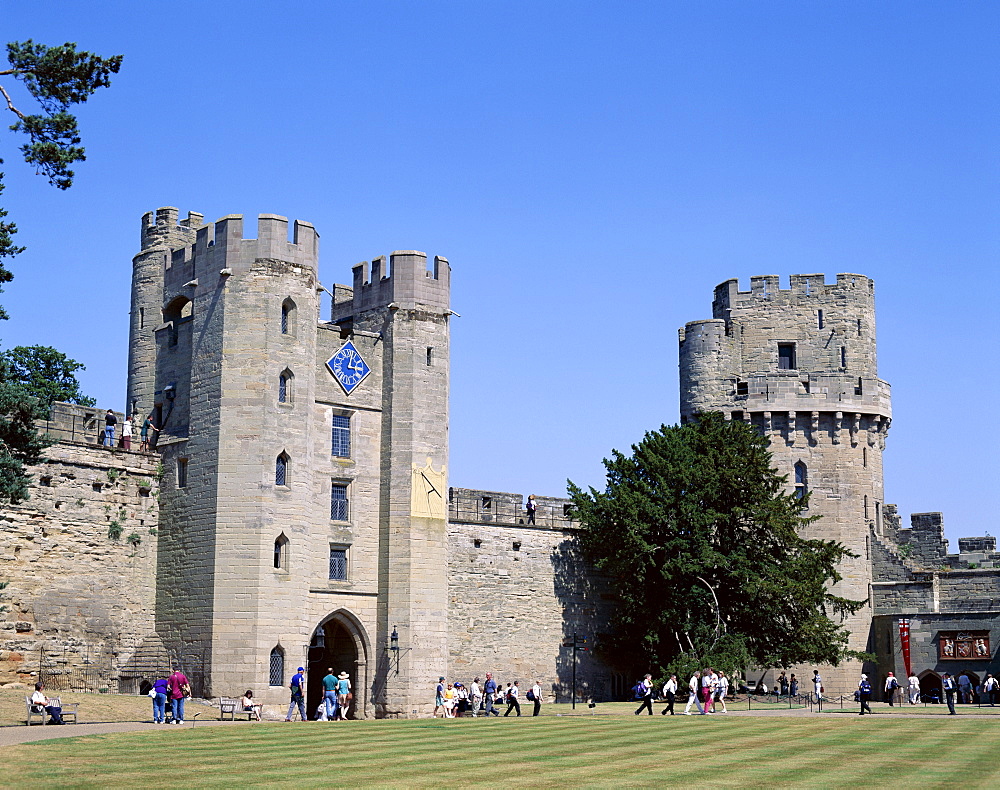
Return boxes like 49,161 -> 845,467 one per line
447,488 -> 612,701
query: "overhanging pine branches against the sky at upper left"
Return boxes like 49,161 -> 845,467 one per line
0,39 -> 122,318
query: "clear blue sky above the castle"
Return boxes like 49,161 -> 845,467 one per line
0,0 -> 1000,550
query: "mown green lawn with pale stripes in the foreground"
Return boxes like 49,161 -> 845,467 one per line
0,714 -> 1000,790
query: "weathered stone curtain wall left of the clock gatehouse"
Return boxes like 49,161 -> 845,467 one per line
0,404 -> 162,690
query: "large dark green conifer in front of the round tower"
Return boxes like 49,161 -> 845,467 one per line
569,413 -> 864,674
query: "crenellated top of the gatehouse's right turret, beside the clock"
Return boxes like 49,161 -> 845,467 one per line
332,250 -> 451,321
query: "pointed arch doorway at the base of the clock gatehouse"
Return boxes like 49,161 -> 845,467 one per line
306,609 -> 372,719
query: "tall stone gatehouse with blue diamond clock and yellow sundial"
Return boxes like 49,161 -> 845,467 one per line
127,208 -> 450,717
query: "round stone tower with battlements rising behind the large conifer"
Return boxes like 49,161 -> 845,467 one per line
680,274 -> 892,693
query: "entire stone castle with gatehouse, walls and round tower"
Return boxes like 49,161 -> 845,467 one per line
0,208 -> 1000,717
